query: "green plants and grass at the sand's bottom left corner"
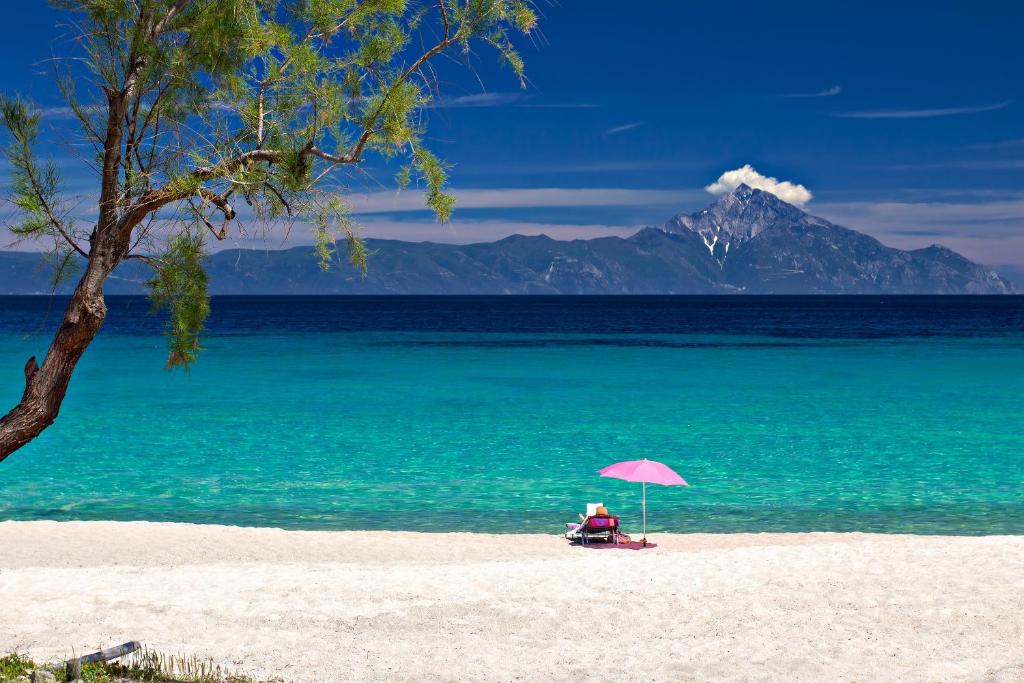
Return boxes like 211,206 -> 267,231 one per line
0,650 -> 282,683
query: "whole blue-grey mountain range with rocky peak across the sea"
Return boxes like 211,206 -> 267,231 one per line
0,185 -> 1012,294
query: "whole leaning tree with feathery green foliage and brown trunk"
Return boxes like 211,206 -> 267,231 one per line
0,0 -> 537,461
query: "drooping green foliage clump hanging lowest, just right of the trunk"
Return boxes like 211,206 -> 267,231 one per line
147,232 -> 210,370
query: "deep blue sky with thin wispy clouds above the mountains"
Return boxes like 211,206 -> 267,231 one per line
0,0 -> 1024,268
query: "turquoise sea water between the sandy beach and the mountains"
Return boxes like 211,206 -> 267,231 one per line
0,301 -> 1024,535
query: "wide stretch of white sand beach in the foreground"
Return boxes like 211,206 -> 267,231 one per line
0,521 -> 1024,682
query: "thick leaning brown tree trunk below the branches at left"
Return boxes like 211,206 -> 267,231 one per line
0,245 -> 120,462
